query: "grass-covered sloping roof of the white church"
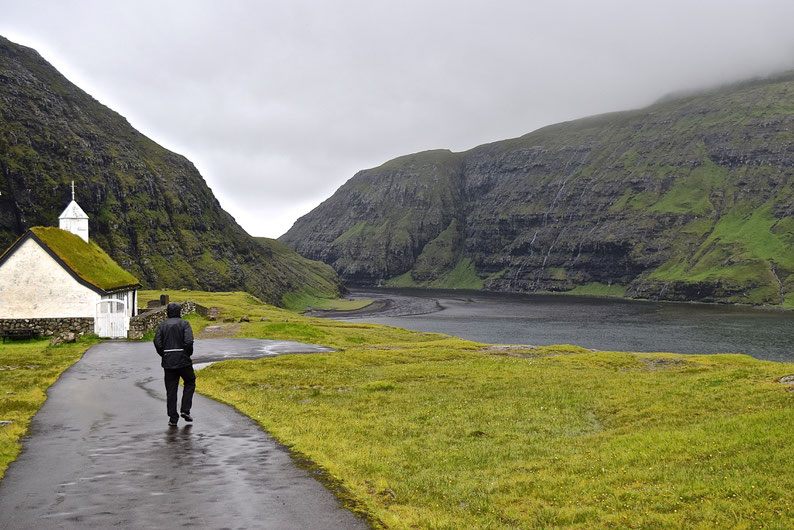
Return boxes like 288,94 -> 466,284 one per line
30,226 -> 140,291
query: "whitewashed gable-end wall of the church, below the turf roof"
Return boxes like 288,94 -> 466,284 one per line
0,239 -> 100,319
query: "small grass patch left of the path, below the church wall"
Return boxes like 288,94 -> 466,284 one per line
0,339 -> 97,480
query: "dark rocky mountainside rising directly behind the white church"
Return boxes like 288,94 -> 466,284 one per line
0,37 -> 341,304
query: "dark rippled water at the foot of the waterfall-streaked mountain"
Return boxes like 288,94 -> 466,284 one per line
345,289 -> 794,362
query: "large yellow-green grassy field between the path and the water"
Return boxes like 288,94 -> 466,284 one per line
139,293 -> 794,528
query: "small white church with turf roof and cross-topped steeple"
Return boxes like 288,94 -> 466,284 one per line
0,183 -> 141,338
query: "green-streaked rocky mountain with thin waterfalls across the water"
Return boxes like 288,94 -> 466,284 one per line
280,72 -> 794,305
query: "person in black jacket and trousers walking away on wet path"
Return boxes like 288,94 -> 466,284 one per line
154,302 -> 196,426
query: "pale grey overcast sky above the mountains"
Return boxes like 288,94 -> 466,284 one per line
0,0 -> 794,237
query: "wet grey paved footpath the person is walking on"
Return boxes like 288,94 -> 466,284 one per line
0,339 -> 367,530
